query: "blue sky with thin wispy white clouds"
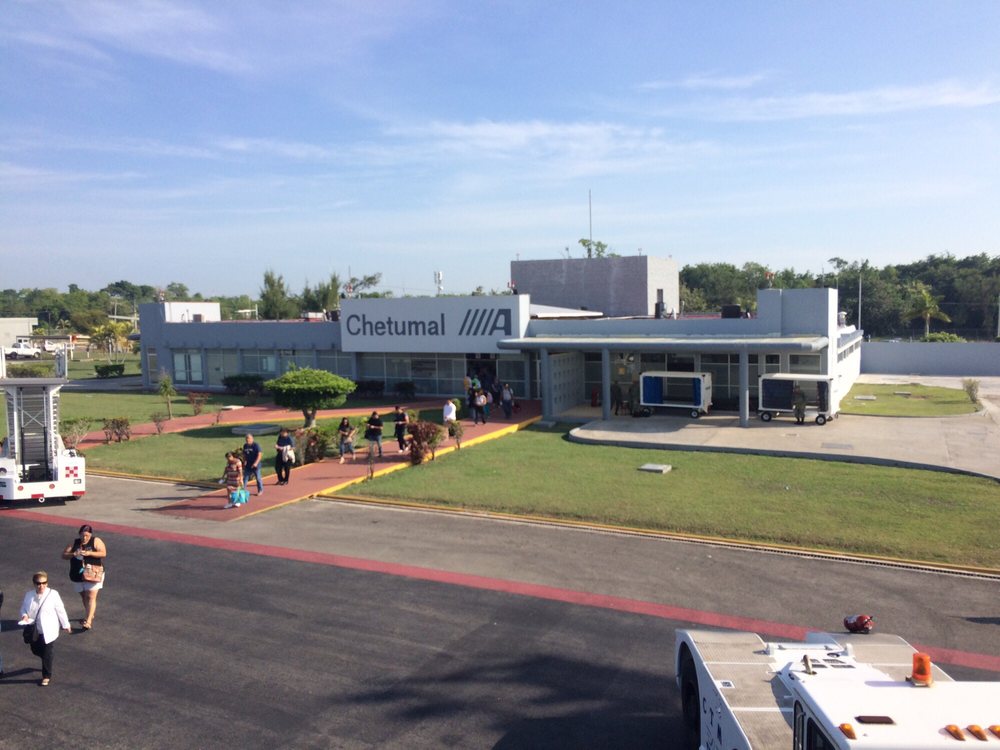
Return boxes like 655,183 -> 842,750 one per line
0,0 -> 1000,296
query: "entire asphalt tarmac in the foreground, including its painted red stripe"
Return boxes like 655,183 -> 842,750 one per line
0,477 -> 1000,748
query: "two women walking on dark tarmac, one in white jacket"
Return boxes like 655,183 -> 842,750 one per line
0,524 -> 108,687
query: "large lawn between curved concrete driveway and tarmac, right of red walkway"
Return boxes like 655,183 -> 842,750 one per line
351,429 -> 1000,568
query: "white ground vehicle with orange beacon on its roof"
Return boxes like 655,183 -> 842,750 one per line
675,630 -> 1000,750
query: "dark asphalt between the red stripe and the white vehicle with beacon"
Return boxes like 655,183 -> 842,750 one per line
0,514 -> 679,750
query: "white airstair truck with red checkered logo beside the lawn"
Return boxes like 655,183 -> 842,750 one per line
0,351 -> 87,503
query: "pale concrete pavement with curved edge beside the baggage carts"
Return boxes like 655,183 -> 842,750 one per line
570,375 -> 1000,480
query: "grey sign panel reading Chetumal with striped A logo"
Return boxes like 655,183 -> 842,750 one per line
341,297 -> 528,352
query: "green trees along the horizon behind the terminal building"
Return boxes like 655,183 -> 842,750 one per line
0,258 -> 1000,340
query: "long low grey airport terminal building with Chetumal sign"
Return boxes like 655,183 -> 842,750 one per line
139,258 -> 862,424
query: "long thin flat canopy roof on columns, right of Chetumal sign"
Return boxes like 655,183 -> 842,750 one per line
497,335 -> 830,352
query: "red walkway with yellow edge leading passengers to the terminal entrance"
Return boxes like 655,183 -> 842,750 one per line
146,400 -> 541,521
